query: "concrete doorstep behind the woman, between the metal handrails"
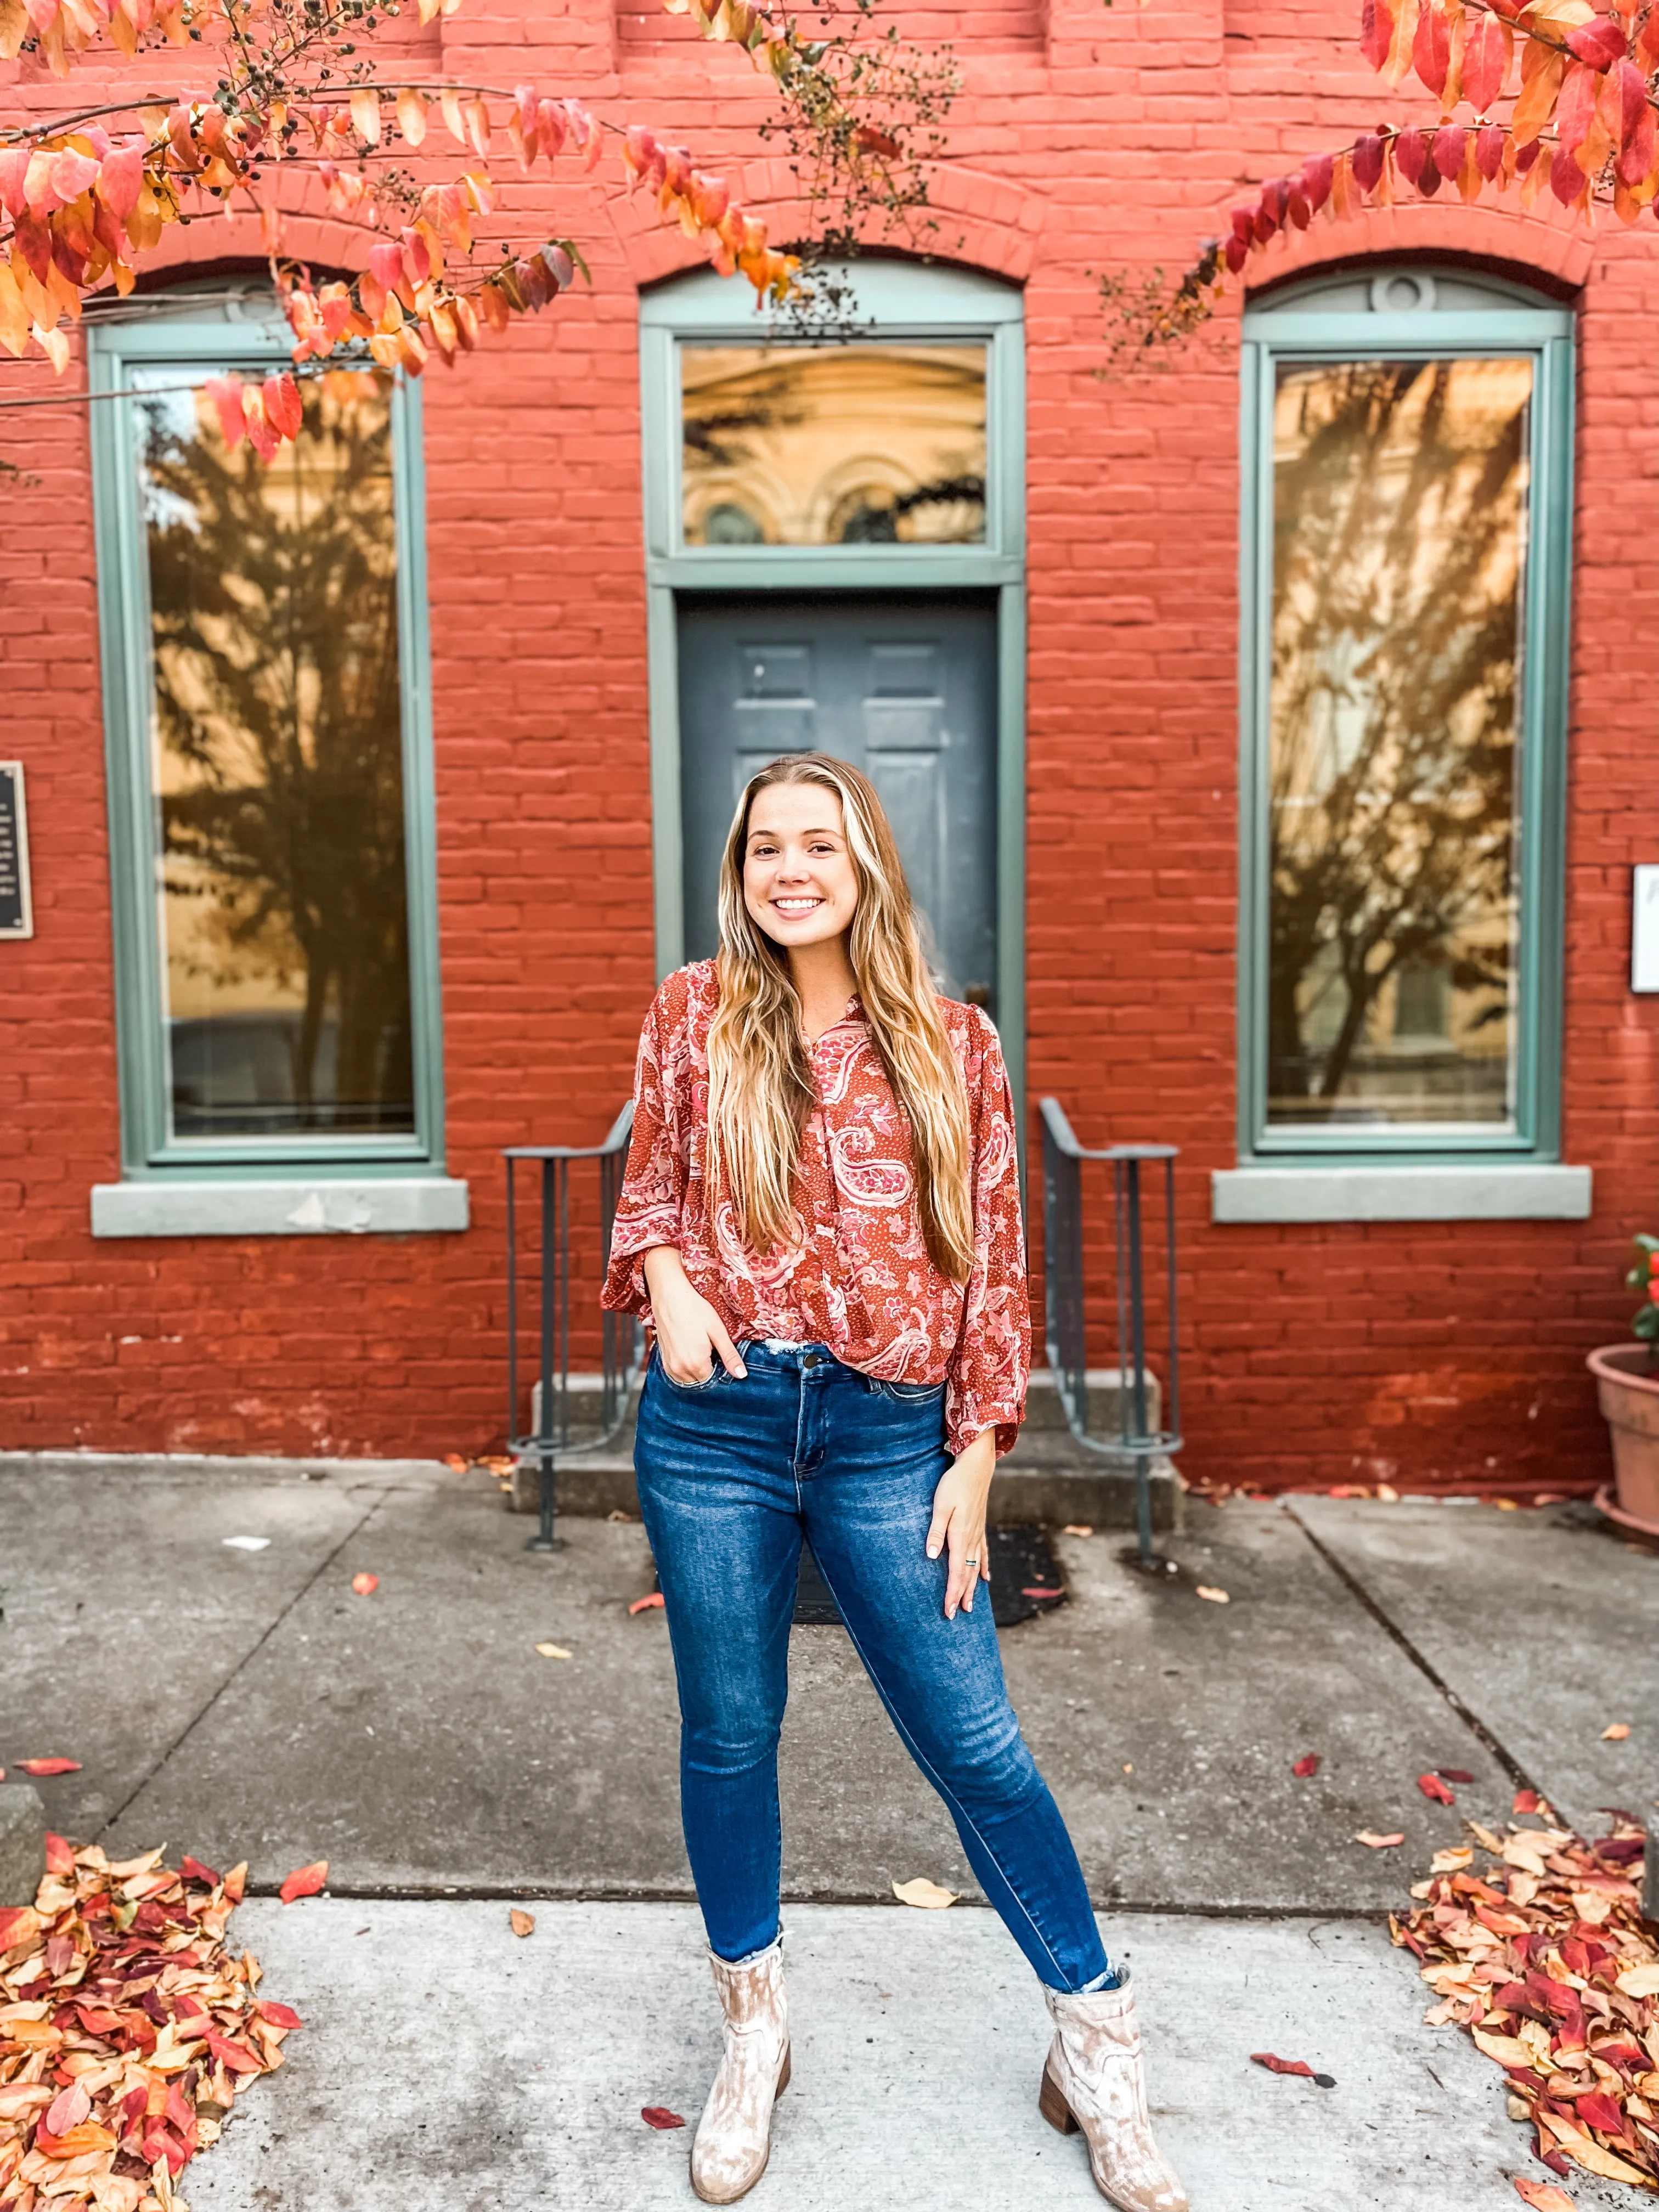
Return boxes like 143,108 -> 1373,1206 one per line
517,1369 -> 1183,1535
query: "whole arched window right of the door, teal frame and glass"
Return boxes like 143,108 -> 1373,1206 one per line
1219,268 -> 1577,1217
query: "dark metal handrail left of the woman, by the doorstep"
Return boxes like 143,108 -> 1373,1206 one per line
502,1099 -> 646,1550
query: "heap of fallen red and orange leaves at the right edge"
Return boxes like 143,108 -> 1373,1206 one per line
1389,1792 -> 1659,2190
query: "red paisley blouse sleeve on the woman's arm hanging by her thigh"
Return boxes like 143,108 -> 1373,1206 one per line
945,1013 -> 1031,1458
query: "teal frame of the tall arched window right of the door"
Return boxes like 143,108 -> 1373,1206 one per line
1239,266 -> 1575,1168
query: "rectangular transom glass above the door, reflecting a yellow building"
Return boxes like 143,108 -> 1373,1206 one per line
679,345 -> 984,546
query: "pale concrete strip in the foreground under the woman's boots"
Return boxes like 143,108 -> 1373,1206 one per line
186,1898 -> 1628,2212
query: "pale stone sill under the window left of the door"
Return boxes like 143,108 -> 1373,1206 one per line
93,1175 -> 467,1237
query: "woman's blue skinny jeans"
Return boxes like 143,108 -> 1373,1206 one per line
635,1342 -> 1117,1991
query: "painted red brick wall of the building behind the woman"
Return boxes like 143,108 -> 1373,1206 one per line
0,0 -> 1659,1491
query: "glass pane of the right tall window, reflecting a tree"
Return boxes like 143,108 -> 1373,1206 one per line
1267,360 -> 1531,1124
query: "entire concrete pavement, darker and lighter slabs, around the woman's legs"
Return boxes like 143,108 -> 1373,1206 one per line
0,1458 -> 1659,2212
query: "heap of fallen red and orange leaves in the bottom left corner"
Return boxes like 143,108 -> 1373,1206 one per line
0,1836 -> 301,2212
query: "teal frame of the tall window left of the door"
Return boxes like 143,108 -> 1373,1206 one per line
88,307 -> 444,1183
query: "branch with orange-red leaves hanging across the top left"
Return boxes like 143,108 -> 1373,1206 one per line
0,0 -> 953,456
